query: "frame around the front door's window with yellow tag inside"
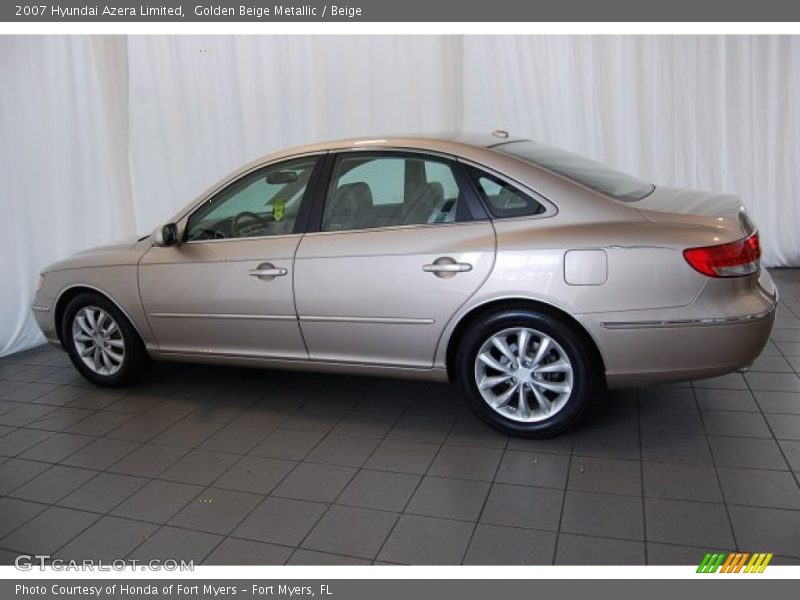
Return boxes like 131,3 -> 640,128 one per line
177,151 -> 328,245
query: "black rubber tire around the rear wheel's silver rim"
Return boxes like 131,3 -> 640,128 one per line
455,308 -> 597,438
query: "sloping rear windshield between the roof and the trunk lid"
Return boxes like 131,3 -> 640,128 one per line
492,141 -> 655,202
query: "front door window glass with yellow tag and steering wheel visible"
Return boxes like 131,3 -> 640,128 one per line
186,156 -> 317,242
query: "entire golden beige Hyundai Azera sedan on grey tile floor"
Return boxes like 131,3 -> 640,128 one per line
33,132 -> 777,436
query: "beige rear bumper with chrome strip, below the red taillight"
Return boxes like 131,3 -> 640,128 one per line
589,272 -> 778,387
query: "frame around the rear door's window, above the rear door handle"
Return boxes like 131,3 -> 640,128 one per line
306,147 -> 490,234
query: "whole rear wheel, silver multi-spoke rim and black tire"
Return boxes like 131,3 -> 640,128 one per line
455,308 -> 596,438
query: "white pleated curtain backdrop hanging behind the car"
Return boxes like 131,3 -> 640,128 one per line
0,36 -> 800,355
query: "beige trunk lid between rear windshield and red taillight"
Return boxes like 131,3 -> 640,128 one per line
633,186 -> 755,240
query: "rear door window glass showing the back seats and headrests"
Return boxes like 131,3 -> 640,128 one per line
322,154 -> 462,231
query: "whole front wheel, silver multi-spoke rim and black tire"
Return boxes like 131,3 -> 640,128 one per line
61,292 -> 150,387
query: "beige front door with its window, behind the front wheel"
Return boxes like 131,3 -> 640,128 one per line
139,156 -> 320,360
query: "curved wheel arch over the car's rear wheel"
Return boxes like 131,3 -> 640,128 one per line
445,297 -> 606,383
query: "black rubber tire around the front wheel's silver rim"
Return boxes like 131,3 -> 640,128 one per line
61,292 -> 150,387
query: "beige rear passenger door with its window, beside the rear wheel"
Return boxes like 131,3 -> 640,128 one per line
295,151 -> 495,368
